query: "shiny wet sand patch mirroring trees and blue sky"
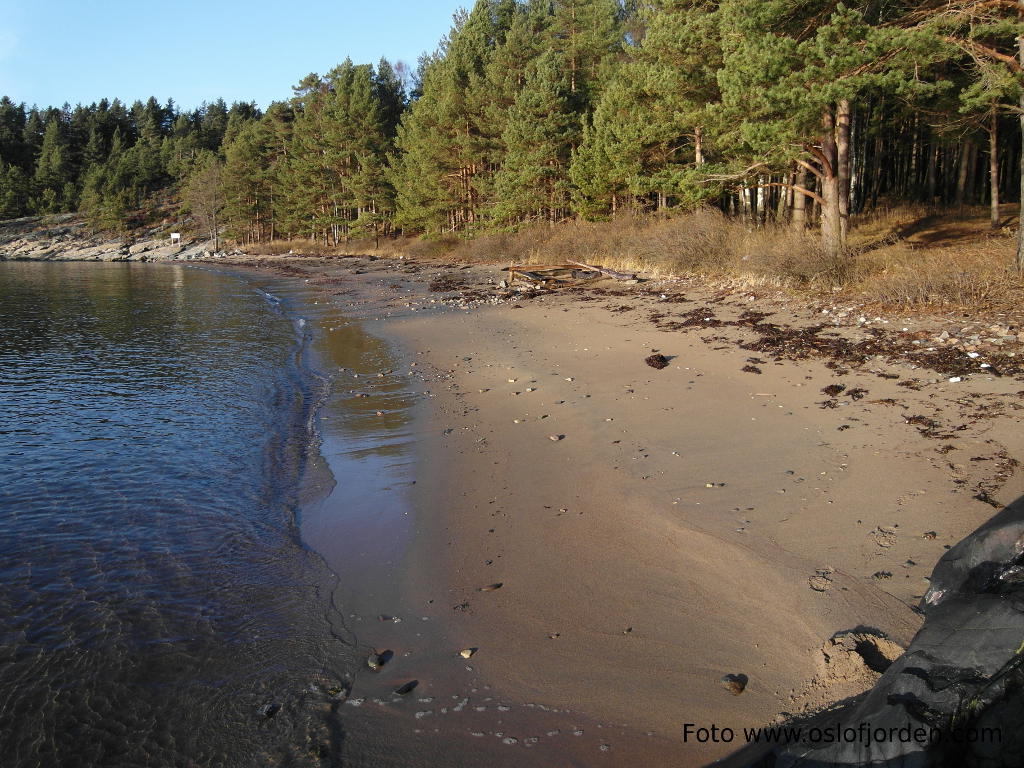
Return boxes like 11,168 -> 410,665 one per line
260,283 -> 414,615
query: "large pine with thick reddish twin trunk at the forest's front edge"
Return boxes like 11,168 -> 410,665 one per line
718,0 -> 921,254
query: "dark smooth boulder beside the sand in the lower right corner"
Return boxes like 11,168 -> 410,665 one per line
717,498 -> 1024,768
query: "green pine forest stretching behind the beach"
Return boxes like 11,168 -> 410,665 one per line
0,0 -> 1024,264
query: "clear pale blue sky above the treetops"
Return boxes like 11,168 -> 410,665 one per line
0,0 -> 471,109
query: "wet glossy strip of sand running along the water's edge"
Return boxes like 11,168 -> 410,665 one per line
242,264 -> 671,766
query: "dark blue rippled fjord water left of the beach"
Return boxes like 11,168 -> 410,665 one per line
0,262 -> 354,766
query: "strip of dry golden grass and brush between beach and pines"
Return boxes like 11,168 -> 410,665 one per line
241,206 -> 1024,310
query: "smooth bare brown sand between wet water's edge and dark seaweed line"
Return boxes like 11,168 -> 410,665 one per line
226,250 -> 1021,765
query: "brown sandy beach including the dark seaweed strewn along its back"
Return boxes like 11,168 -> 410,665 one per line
230,259 -> 1024,765
